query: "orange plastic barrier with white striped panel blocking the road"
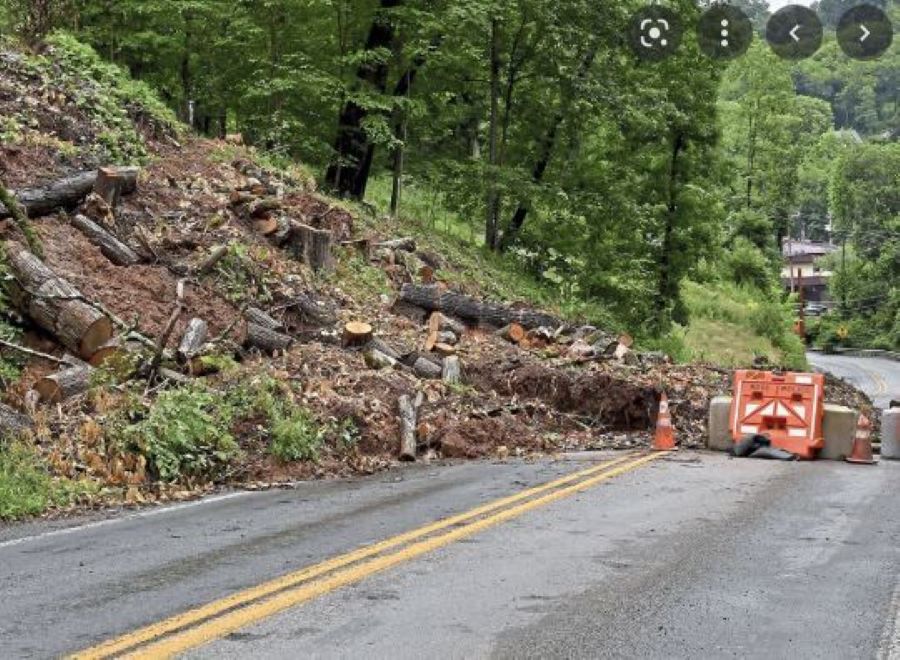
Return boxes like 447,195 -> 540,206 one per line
731,371 -> 825,459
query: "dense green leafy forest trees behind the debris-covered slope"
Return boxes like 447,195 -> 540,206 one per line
0,0 -> 900,348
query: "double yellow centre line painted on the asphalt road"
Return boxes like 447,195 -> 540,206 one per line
73,452 -> 665,659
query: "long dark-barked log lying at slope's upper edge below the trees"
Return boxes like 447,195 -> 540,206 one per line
399,284 -> 562,330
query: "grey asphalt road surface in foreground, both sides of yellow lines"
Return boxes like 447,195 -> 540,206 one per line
0,452 -> 900,658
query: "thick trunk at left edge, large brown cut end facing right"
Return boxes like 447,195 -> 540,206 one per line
7,244 -> 113,360
